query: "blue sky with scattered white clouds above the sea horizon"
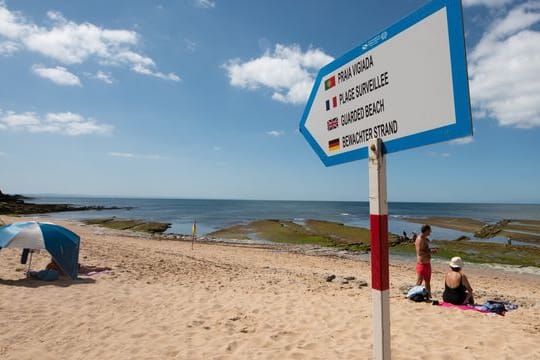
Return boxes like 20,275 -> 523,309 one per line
0,0 -> 540,203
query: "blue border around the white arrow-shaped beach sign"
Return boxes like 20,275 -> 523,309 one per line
300,0 -> 472,166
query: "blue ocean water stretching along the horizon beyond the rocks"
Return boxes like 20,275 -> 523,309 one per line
29,196 -> 540,243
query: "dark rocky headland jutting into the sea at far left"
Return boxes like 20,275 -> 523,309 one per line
0,190 -> 130,215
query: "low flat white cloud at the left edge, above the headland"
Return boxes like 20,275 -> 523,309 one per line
0,110 -> 113,136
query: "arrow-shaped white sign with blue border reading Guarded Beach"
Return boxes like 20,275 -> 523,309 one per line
300,0 -> 472,166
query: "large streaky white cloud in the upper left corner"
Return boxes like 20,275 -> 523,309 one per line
0,2 -> 180,81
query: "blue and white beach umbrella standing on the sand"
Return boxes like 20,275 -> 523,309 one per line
0,221 -> 80,279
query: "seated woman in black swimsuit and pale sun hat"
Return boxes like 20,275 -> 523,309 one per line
443,256 -> 474,305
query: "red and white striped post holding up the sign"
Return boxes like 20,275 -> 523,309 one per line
368,139 -> 391,360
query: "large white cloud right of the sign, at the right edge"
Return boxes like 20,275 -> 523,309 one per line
469,1 -> 540,128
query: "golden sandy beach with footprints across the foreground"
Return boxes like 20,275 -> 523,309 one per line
0,217 -> 540,359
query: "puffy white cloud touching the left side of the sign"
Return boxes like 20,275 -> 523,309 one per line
223,44 -> 333,104
